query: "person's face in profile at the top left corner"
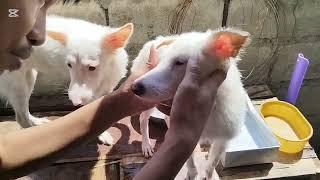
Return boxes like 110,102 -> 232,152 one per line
0,0 -> 56,74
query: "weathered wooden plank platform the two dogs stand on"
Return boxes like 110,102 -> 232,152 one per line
0,86 -> 320,180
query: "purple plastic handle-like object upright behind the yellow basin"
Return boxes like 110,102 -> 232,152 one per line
286,53 -> 309,105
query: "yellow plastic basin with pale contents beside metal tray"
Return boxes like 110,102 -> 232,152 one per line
260,101 -> 313,153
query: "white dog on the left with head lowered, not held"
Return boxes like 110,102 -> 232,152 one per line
0,16 -> 133,144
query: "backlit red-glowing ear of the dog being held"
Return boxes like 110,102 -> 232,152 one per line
205,31 -> 249,60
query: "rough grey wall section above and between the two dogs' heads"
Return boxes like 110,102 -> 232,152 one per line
108,0 -> 223,57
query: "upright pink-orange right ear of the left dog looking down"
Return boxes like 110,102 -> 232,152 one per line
102,23 -> 133,50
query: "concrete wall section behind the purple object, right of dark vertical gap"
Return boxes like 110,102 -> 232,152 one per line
228,0 -> 320,152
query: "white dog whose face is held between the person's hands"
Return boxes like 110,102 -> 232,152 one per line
132,29 -> 249,179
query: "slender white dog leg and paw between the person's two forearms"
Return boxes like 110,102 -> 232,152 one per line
140,108 -> 154,157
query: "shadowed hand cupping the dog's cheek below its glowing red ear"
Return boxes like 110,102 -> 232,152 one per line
168,57 -> 226,141
